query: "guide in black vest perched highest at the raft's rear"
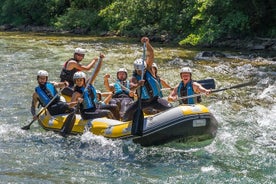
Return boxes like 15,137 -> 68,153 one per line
60,48 -> 101,96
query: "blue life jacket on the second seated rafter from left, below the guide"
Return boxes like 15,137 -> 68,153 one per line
81,84 -> 98,110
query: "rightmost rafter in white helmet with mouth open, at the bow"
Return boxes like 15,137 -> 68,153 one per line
168,67 -> 211,104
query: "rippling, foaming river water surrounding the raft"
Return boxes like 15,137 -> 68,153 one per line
0,33 -> 276,184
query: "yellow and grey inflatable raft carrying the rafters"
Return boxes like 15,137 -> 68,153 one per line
39,104 -> 218,146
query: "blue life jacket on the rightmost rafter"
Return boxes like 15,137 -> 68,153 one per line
177,81 -> 197,104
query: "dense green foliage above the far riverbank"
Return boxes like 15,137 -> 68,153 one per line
0,0 -> 276,45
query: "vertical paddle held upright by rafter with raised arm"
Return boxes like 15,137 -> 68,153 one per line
131,42 -> 146,136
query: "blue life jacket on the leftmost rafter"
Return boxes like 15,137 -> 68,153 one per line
35,82 -> 59,107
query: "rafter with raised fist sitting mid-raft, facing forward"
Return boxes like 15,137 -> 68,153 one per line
104,68 -> 134,118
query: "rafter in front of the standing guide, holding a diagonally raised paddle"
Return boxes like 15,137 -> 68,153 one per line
71,72 -> 120,120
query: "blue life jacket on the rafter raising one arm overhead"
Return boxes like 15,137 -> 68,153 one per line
135,70 -> 162,100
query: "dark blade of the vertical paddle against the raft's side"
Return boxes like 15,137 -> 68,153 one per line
131,109 -> 144,136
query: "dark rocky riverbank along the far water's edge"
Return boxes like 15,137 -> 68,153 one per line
0,25 -> 276,54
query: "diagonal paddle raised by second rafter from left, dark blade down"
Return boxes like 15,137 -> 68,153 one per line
60,57 -> 102,137
